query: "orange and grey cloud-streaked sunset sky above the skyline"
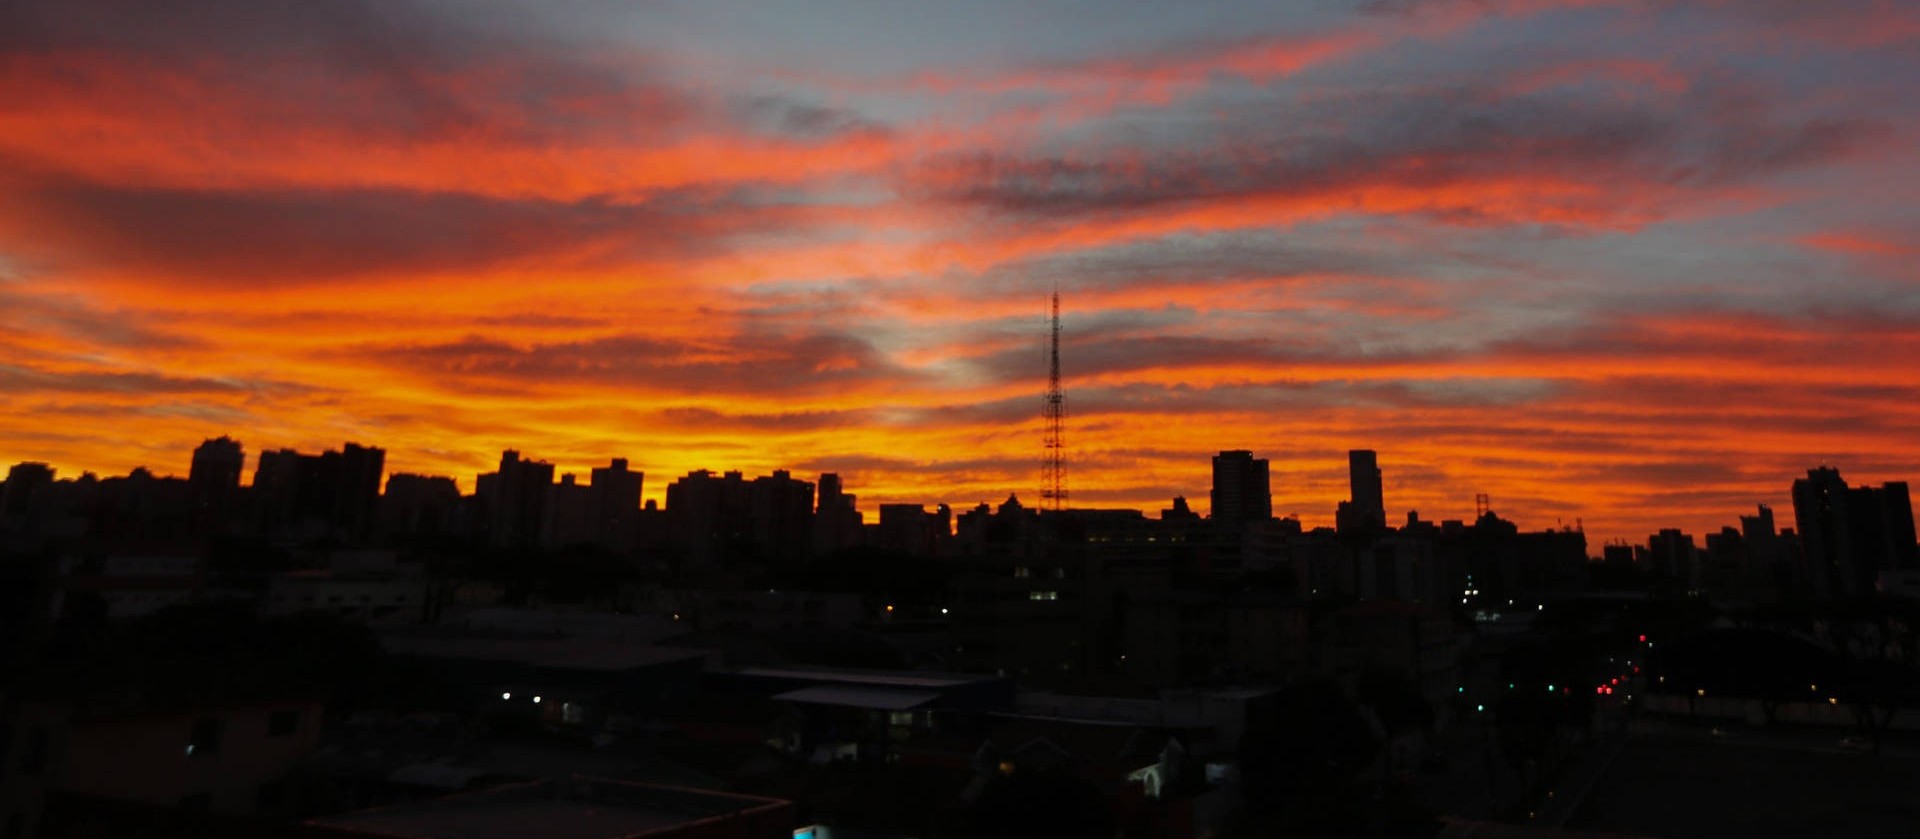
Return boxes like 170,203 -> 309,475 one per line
0,0 -> 1920,551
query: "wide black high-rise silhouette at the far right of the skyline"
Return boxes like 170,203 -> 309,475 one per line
1793,467 -> 1916,599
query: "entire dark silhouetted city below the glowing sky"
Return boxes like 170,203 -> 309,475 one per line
0,428 -> 1920,837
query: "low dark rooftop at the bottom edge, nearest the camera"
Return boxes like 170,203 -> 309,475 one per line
307,778 -> 793,839
